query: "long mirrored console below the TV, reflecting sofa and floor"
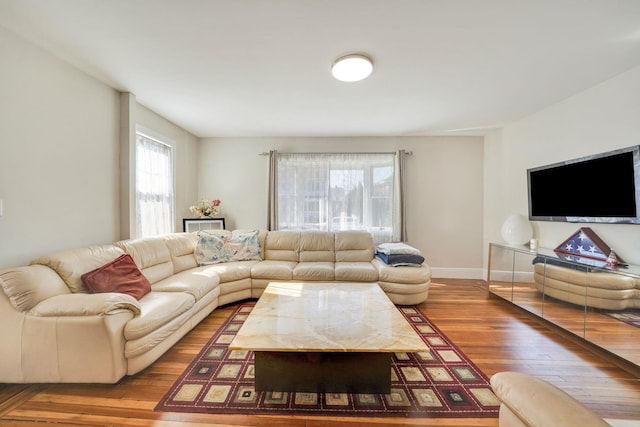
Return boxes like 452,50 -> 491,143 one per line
487,243 -> 640,366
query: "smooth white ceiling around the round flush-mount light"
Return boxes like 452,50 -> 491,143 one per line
0,0 -> 640,137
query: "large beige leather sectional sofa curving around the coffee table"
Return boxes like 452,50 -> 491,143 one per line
0,231 -> 431,383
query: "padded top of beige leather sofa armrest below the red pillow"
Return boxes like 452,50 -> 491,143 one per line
29,292 -> 140,317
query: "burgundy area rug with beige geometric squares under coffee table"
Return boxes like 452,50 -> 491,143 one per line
155,301 -> 500,418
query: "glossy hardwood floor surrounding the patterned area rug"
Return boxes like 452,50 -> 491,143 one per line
0,279 -> 640,427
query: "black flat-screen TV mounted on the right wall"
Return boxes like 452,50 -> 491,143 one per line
527,145 -> 640,224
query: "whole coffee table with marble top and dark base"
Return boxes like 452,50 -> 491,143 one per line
229,282 -> 429,393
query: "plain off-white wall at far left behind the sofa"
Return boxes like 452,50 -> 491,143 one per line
0,28 -> 119,266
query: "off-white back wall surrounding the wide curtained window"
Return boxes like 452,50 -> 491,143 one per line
200,137 -> 483,278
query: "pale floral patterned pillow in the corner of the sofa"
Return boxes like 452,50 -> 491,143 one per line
194,230 -> 262,265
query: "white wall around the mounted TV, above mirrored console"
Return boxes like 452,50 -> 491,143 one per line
484,67 -> 640,270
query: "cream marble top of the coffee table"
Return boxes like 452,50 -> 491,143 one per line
229,282 -> 428,352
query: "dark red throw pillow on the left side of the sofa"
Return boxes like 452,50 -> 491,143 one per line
81,254 -> 151,299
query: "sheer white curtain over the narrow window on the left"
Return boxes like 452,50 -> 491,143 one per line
136,133 -> 174,237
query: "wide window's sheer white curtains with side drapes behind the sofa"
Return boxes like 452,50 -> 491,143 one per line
268,152 -> 404,243
